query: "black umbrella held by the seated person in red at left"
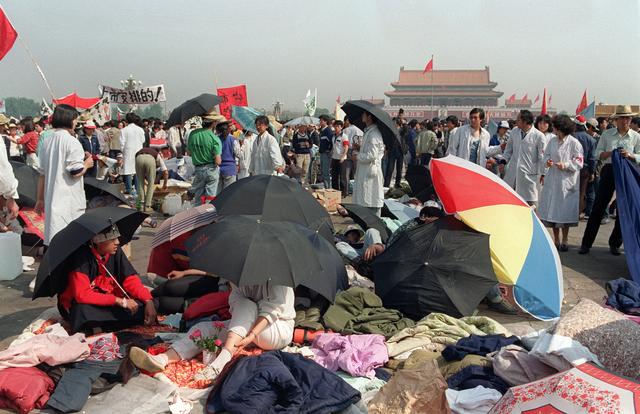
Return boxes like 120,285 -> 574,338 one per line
33,207 -> 147,299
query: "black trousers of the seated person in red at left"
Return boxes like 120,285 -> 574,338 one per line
58,301 -> 144,332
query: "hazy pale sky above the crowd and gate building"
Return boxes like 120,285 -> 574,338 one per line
0,0 -> 640,111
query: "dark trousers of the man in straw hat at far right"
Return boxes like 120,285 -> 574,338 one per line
582,164 -> 622,248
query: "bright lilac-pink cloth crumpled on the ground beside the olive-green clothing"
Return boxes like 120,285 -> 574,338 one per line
311,333 -> 389,378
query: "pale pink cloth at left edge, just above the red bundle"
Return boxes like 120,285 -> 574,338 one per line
0,334 -> 89,370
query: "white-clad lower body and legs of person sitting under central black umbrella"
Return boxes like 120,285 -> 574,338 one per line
130,283 -> 296,379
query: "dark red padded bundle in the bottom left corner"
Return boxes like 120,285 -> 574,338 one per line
0,368 -> 55,413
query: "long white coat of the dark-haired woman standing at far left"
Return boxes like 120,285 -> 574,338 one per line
39,129 -> 87,246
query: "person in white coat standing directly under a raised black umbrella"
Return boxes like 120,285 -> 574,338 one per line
353,111 -> 384,216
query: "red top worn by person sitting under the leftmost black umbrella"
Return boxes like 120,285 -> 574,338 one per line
58,249 -> 153,310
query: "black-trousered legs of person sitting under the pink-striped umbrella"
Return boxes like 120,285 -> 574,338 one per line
151,276 -> 220,315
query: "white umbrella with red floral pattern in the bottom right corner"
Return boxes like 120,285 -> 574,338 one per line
489,363 -> 640,414
